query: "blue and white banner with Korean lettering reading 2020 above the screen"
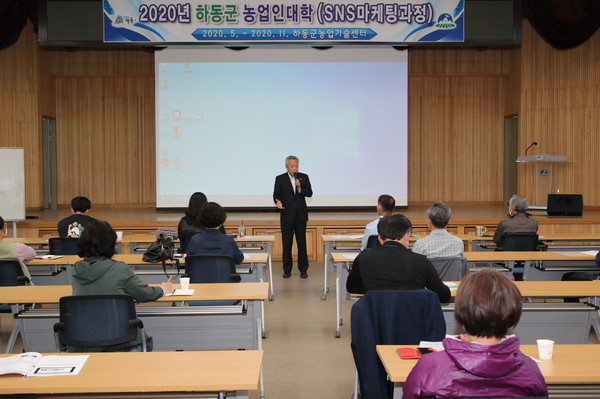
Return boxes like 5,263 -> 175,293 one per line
103,0 -> 464,44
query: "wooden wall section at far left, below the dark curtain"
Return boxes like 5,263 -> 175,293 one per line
0,24 -> 43,207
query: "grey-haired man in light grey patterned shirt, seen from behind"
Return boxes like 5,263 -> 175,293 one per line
412,202 -> 465,258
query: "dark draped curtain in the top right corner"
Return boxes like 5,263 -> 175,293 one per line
523,0 -> 600,49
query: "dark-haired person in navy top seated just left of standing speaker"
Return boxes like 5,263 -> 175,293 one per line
186,202 -> 244,265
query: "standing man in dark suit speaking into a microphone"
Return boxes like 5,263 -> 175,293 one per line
273,155 -> 312,278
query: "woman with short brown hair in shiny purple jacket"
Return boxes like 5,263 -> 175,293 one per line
402,269 -> 548,399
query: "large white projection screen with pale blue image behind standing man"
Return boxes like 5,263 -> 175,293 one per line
155,46 -> 408,208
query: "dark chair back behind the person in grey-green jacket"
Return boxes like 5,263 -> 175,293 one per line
54,294 -> 147,352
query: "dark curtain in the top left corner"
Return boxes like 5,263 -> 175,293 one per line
0,0 -> 38,50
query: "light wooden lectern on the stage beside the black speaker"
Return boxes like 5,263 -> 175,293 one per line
517,154 -> 570,209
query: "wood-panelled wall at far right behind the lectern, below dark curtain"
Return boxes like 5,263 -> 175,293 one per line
519,22 -> 600,206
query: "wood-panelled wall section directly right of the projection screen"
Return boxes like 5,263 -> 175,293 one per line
409,76 -> 506,202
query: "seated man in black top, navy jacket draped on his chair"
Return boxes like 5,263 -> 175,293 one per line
346,214 -> 450,302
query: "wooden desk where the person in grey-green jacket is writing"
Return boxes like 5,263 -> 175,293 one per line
0,283 -> 269,396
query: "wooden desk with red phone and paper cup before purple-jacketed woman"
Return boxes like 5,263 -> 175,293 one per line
377,344 -> 600,399
